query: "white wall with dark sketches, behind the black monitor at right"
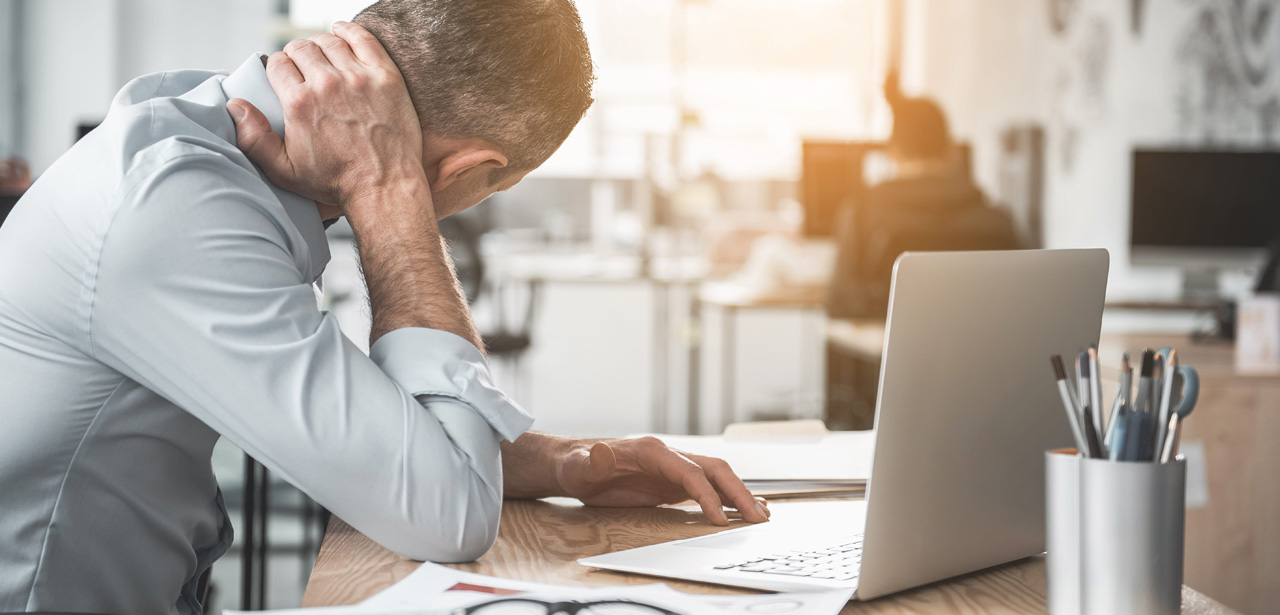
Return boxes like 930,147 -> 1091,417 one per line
904,0 -> 1280,299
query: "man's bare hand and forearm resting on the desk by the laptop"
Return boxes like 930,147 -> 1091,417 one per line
503,433 -> 769,525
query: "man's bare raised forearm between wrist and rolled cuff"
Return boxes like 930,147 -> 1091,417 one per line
344,179 -> 484,352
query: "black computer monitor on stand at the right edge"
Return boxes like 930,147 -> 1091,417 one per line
1129,150 -> 1280,295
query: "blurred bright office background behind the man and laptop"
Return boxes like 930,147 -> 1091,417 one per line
0,0 -> 1280,612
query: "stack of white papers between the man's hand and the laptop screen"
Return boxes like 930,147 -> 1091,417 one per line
640,431 -> 876,480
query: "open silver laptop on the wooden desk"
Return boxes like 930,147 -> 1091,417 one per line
579,250 -> 1108,600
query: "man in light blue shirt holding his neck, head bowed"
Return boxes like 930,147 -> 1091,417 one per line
0,0 -> 768,614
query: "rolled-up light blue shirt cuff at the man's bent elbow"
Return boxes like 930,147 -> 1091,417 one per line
369,327 -> 534,442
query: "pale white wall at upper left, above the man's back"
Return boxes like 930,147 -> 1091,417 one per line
13,0 -> 274,174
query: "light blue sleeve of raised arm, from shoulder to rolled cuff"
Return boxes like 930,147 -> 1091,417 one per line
86,152 -> 532,561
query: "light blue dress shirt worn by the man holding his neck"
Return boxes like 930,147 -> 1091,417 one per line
0,56 -> 532,615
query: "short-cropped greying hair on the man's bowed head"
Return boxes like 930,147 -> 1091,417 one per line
353,0 -> 595,181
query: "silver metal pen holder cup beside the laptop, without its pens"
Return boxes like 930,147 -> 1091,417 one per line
1044,450 -> 1187,615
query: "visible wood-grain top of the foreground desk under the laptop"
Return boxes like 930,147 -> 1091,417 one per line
302,501 -> 1233,615
